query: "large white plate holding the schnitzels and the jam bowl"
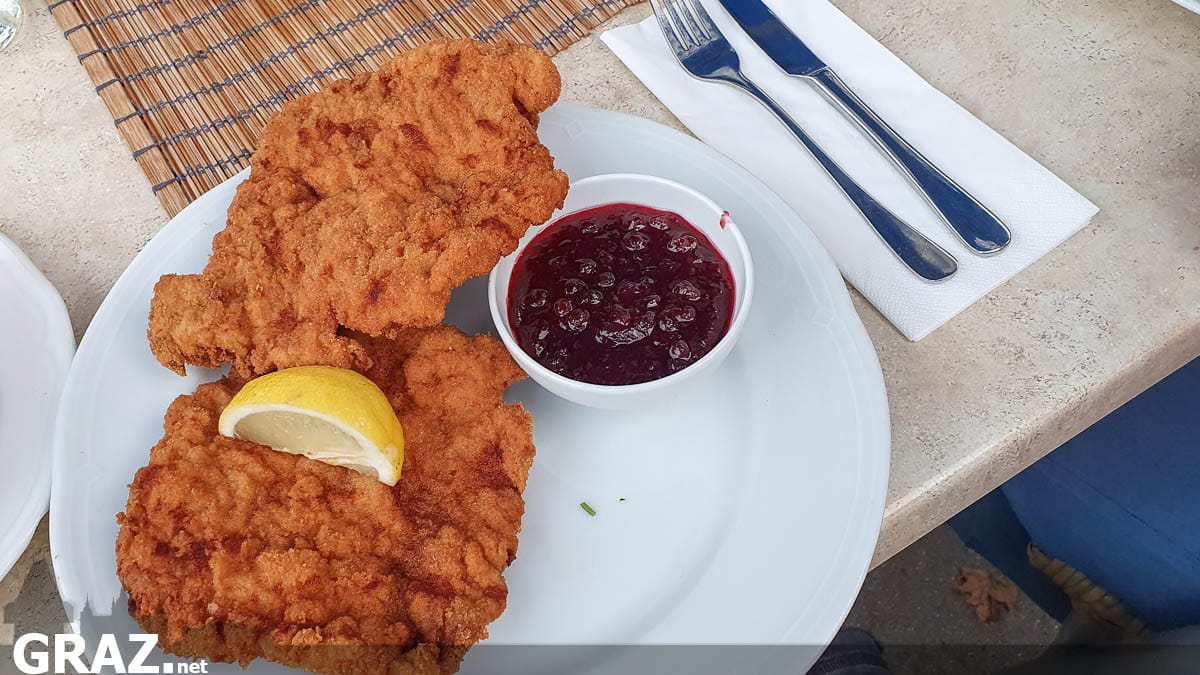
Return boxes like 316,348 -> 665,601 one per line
50,104 -> 889,673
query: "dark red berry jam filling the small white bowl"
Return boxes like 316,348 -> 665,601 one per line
509,204 -> 733,384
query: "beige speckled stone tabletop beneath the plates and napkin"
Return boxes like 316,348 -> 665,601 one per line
0,0 -> 1200,624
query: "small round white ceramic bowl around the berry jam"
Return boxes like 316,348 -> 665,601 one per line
487,173 -> 754,410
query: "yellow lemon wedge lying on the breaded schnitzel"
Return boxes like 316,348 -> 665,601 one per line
218,365 -> 404,485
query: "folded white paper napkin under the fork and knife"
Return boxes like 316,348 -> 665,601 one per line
602,0 -> 1097,340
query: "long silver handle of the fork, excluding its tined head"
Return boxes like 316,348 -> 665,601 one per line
714,70 -> 959,281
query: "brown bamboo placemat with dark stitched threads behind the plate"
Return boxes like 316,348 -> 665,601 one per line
49,0 -> 638,215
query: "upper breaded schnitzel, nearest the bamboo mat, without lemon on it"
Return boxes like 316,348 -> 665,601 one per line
149,40 -> 566,376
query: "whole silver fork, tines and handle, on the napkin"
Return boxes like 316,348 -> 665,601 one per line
650,0 -> 959,281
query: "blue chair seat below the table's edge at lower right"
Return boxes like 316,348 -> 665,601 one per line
950,359 -> 1200,631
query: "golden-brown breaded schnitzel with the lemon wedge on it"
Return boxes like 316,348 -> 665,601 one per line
116,327 -> 534,674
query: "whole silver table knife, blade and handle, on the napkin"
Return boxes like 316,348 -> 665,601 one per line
721,0 -> 1013,256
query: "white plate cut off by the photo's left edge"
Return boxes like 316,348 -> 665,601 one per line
0,234 -> 74,579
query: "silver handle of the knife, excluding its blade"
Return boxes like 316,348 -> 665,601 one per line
803,67 -> 1013,256
